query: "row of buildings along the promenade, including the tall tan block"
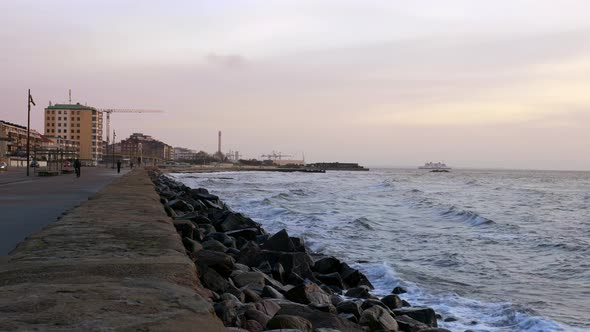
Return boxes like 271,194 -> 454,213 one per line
0,103 -> 174,166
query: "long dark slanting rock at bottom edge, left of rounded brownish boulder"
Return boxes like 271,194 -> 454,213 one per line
273,300 -> 363,332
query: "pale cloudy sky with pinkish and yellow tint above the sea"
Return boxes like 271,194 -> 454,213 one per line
0,0 -> 590,170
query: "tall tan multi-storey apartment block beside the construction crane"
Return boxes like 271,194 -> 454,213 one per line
45,103 -> 103,165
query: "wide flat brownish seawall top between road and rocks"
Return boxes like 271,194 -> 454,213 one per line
0,170 -> 225,331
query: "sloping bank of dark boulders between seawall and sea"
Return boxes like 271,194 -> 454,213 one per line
152,173 -> 447,332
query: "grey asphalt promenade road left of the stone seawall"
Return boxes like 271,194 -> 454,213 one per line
0,167 -> 128,256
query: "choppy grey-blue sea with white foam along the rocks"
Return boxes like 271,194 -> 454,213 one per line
174,169 -> 590,331
